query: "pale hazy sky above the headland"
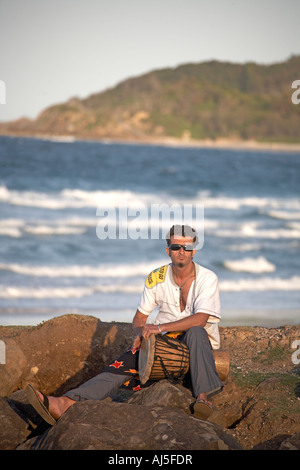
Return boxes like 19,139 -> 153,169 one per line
0,0 -> 300,122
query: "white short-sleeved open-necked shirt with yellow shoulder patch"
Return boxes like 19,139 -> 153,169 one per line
138,263 -> 221,349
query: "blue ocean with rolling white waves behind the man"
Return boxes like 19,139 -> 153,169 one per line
0,137 -> 300,327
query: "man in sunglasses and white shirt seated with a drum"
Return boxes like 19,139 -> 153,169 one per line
27,225 -> 223,424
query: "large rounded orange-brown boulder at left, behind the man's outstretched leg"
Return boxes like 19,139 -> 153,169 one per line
0,315 -> 132,396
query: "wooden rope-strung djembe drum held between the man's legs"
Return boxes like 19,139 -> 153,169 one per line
139,335 -> 230,384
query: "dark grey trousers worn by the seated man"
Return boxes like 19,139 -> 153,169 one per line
65,326 -> 223,401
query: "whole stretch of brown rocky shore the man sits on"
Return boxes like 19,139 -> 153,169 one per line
0,315 -> 300,450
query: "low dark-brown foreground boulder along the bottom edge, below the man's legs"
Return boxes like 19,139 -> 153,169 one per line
17,400 -> 241,451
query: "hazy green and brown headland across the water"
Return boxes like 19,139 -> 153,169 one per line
0,56 -> 300,143
